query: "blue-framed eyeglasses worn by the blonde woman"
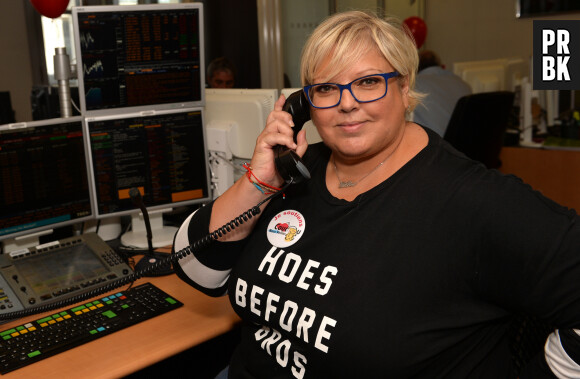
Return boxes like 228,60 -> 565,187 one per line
304,71 -> 399,109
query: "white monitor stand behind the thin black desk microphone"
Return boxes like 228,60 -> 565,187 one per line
121,208 -> 177,249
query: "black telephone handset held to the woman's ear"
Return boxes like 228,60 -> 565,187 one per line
274,90 -> 310,183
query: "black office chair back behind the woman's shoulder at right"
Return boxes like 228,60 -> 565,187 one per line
443,91 -> 515,168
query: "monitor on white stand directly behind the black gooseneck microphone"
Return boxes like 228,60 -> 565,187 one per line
85,108 -> 211,248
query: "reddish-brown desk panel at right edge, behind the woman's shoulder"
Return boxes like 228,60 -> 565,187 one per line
499,146 -> 580,212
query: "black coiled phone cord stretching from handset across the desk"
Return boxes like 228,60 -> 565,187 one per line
0,180 -> 294,321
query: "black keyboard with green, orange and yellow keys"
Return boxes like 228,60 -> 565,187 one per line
0,283 -> 183,374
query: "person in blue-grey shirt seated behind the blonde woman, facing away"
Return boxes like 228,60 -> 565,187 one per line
413,50 -> 471,137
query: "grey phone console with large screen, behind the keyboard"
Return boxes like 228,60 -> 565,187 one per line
0,233 -> 133,314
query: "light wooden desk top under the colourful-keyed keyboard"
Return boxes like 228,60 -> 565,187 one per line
0,256 -> 239,379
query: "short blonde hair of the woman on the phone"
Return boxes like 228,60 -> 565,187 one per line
300,11 -> 422,112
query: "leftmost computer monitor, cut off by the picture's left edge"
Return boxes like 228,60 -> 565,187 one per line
0,117 -> 94,253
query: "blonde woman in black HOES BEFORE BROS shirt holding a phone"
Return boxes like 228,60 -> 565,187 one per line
175,12 -> 580,378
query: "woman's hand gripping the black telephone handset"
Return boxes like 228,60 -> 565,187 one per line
250,95 -> 308,187
